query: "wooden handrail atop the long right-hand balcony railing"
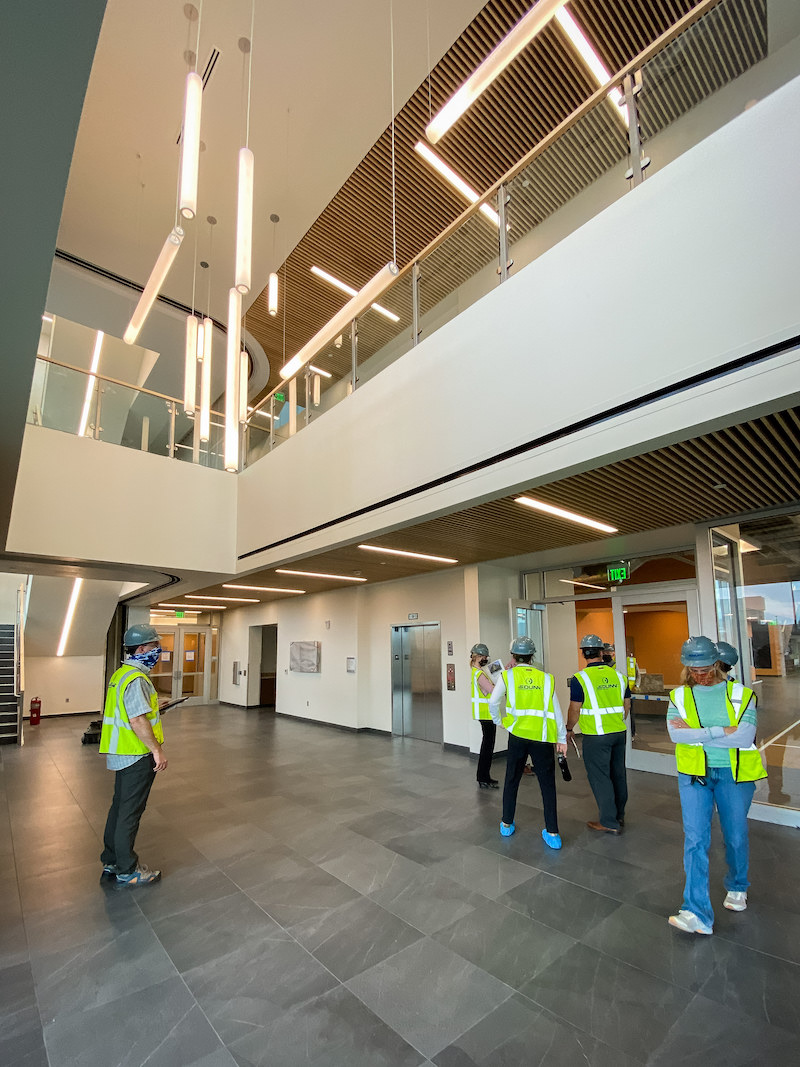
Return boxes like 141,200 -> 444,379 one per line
245,0 -> 723,427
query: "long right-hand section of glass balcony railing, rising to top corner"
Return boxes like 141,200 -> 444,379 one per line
245,0 -> 800,464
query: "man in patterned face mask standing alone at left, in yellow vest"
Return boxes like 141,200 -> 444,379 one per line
100,625 -> 166,887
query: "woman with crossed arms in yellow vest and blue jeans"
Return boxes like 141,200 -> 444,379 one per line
667,637 -> 767,934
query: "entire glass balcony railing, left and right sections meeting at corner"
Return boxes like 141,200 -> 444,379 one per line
29,0 -> 800,467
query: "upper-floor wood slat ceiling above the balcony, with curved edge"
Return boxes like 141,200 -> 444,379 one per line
246,0 -> 767,393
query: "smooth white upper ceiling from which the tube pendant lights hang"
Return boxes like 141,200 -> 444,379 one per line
59,0 -> 482,320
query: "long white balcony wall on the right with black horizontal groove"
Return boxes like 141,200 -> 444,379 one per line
238,80 -> 800,567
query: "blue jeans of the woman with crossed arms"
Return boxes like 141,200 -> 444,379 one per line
677,767 -> 755,926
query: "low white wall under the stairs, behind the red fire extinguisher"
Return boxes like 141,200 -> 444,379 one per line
25,656 -> 106,712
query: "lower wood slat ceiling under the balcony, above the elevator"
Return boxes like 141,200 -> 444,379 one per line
167,408 -> 800,606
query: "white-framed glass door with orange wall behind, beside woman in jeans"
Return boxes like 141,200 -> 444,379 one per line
613,587 -> 700,775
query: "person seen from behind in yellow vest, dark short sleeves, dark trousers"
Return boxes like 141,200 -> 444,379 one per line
566,634 -> 630,834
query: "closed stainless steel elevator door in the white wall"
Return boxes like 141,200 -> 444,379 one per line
391,622 -> 443,745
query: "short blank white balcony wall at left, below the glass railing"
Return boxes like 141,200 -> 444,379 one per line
6,426 -> 236,574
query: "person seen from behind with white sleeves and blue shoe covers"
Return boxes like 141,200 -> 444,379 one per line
489,637 -> 566,848
